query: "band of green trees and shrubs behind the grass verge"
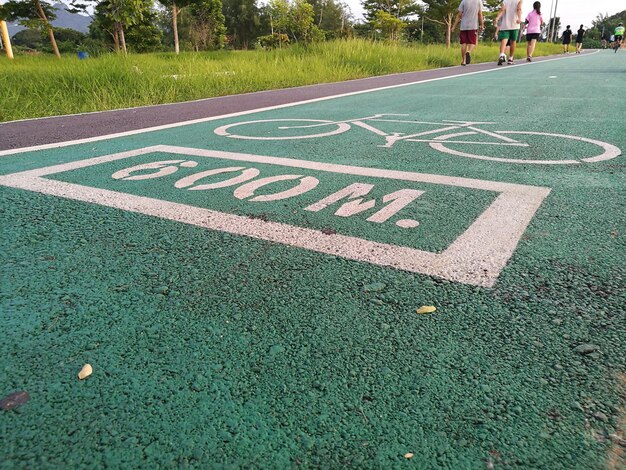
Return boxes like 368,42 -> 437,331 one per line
0,0 -> 626,55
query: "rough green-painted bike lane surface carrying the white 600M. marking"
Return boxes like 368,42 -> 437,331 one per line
0,52 -> 626,468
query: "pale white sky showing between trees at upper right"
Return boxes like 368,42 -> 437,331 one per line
344,0 -> 626,29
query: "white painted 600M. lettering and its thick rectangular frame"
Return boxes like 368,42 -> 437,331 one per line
0,145 -> 550,287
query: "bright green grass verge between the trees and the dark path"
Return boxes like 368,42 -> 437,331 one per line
0,40 -> 560,122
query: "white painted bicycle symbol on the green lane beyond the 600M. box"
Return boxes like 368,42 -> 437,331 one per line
214,114 -> 622,165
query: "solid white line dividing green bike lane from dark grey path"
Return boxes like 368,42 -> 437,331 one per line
0,51 -> 596,157
